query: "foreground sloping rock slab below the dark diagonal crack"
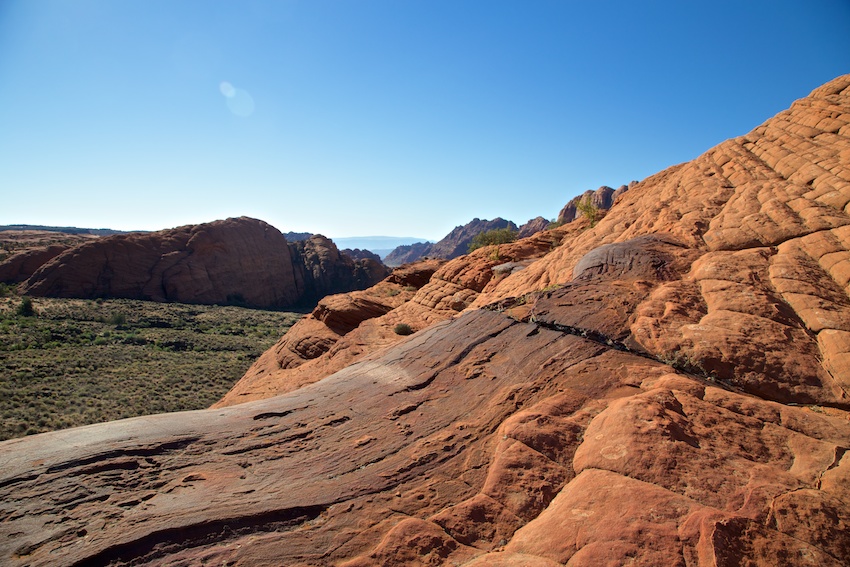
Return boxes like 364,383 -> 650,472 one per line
0,310 -> 850,567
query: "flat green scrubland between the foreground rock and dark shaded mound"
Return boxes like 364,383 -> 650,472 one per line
0,296 -> 301,440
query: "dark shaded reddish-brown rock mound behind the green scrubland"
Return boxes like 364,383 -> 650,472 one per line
15,217 -> 387,307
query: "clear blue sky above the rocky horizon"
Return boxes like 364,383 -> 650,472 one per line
0,0 -> 850,240
